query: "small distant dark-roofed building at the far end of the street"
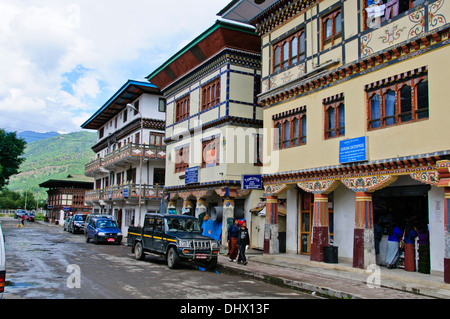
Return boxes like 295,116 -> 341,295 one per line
39,174 -> 94,225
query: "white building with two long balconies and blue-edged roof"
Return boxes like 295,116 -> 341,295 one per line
81,80 -> 166,233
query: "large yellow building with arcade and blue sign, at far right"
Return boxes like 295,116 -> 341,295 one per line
222,0 -> 450,282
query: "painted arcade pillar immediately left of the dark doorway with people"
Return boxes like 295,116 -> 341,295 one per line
353,192 -> 376,269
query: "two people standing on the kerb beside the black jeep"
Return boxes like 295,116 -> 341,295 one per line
228,218 -> 250,265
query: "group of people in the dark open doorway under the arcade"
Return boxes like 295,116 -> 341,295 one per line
374,222 -> 430,274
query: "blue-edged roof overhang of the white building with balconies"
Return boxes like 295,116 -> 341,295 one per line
81,80 -> 161,130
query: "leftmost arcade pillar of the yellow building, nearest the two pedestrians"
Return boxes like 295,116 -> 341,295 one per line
264,196 -> 280,255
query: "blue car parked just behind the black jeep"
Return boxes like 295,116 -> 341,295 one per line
85,218 -> 122,245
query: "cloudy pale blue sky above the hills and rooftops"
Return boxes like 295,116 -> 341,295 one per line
0,0 -> 231,133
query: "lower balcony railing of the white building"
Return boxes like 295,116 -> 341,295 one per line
85,183 -> 164,202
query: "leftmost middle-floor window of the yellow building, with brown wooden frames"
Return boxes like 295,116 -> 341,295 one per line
273,107 -> 306,149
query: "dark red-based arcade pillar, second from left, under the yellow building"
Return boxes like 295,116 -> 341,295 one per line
310,194 -> 330,261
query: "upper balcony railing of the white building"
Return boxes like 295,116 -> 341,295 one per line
84,143 -> 166,176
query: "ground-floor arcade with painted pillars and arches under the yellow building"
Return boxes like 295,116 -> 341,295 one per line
263,157 -> 449,282
